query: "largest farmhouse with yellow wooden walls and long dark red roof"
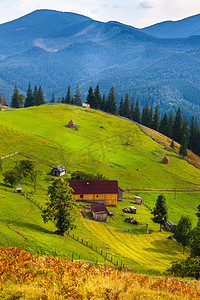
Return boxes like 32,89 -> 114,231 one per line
70,180 -> 122,206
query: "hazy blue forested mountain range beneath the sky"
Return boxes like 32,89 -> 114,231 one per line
0,9 -> 200,116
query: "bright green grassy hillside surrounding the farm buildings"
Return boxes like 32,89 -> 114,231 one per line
0,104 -> 200,273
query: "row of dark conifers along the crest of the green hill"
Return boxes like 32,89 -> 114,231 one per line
4,83 -> 200,156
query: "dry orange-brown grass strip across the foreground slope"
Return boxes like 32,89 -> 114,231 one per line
0,247 -> 200,300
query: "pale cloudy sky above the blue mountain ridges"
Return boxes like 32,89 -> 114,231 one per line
0,0 -> 200,28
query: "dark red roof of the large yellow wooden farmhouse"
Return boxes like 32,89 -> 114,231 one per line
70,180 -> 118,194
